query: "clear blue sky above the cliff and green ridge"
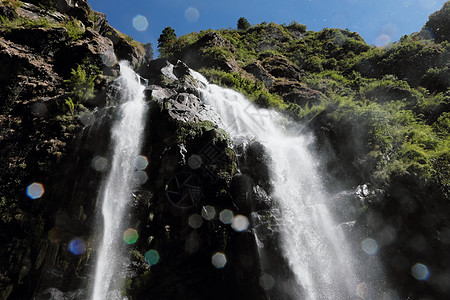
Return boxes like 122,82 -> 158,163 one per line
88,0 -> 446,52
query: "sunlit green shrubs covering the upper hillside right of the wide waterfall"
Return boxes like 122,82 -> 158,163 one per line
160,2 -> 450,198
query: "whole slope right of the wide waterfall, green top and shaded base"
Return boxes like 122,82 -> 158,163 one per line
156,1 -> 450,299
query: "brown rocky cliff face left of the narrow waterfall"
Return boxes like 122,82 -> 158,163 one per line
0,1 -> 149,299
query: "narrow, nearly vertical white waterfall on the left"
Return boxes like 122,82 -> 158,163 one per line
92,62 -> 146,300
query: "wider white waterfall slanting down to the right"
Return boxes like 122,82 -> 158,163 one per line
191,71 -> 357,300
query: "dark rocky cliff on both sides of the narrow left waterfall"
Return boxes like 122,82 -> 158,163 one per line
0,1 -> 265,299
